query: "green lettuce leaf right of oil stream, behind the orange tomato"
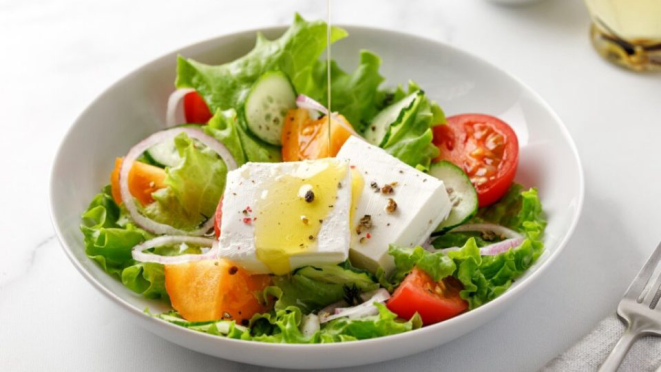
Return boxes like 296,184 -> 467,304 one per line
310,50 -> 385,132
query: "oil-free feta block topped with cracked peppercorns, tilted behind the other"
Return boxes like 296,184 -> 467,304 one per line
337,137 -> 452,272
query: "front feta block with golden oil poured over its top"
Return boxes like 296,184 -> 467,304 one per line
219,159 -> 352,275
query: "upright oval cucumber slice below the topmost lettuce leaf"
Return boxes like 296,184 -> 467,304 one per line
244,71 -> 296,145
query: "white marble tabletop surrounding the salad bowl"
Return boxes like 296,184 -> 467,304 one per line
0,0 -> 661,371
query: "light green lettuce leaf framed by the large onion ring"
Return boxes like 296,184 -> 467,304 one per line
144,133 -> 227,230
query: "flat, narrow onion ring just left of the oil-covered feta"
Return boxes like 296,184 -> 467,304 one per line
131,235 -> 219,265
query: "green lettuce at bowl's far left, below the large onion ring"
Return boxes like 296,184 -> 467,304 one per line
80,186 -> 168,300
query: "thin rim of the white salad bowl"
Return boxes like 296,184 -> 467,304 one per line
49,24 -> 585,350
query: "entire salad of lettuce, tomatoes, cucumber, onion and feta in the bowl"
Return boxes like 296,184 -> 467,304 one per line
81,16 -> 546,344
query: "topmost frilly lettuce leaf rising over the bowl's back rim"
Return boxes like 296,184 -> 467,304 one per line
175,14 -> 347,112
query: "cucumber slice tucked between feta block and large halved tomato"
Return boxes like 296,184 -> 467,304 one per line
429,160 -> 477,236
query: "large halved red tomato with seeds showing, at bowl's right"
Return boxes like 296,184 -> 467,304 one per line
434,114 -> 519,207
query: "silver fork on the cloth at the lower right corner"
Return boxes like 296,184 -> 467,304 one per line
599,243 -> 661,372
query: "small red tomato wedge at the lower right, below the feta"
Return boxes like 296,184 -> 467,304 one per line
386,268 -> 468,325
